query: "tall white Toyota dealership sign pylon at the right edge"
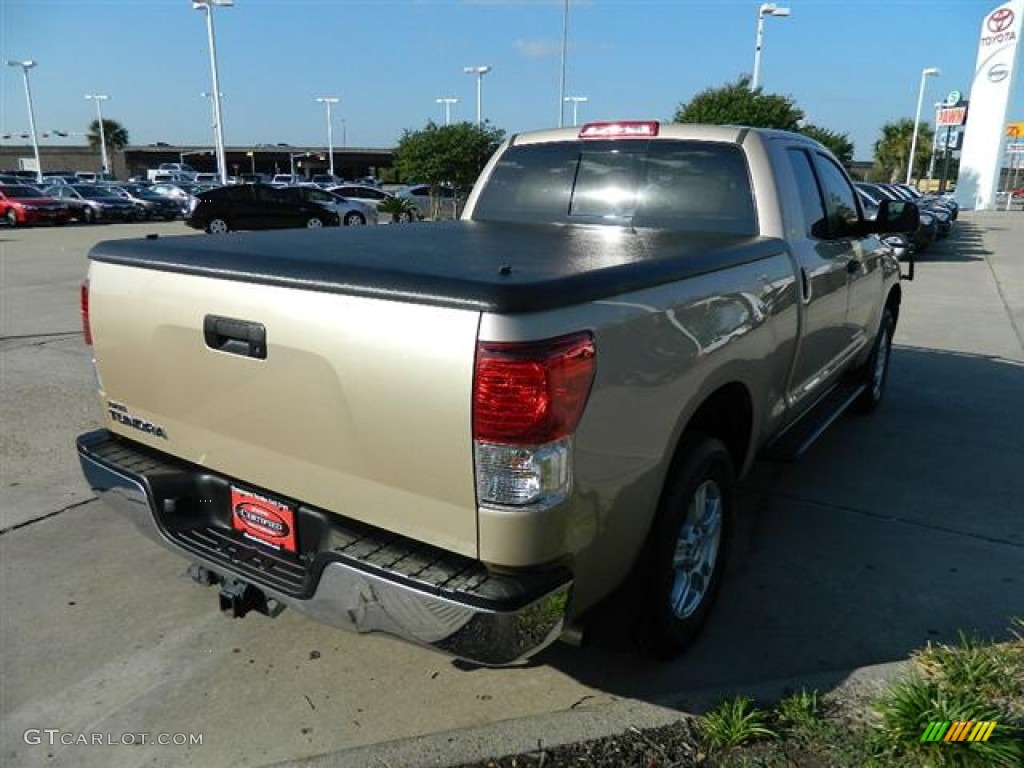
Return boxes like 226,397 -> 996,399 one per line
956,0 -> 1024,210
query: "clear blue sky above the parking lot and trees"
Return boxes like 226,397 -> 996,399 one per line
0,0 -> 1024,159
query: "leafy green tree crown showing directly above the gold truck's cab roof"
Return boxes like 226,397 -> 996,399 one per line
674,75 -> 804,131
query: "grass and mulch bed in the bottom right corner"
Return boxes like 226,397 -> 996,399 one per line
456,618 -> 1024,768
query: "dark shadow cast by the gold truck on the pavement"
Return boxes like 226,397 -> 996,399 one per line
537,347 -> 1024,703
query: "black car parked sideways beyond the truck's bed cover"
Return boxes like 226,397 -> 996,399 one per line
185,184 -> 339,234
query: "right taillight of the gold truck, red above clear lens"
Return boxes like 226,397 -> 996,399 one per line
473,333 -> 597,506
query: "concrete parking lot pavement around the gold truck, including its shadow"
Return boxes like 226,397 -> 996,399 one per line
0,217 -> 1024,768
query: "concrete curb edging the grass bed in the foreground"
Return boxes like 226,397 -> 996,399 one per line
267,662 -> 908,768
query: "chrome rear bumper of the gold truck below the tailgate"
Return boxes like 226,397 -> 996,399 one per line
77,430 -> 572,666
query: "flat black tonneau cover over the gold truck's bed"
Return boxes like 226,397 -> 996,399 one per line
89,221 -> 785,314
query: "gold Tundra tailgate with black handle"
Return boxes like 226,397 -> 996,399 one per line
89,261 -> 479,557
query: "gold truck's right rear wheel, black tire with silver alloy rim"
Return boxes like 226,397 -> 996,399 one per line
637,434 -> 736,659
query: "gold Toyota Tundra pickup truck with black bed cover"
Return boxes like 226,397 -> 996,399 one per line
78,122 -> 918,665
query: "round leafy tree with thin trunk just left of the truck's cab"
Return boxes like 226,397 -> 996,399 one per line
394,121 -> 505,216
